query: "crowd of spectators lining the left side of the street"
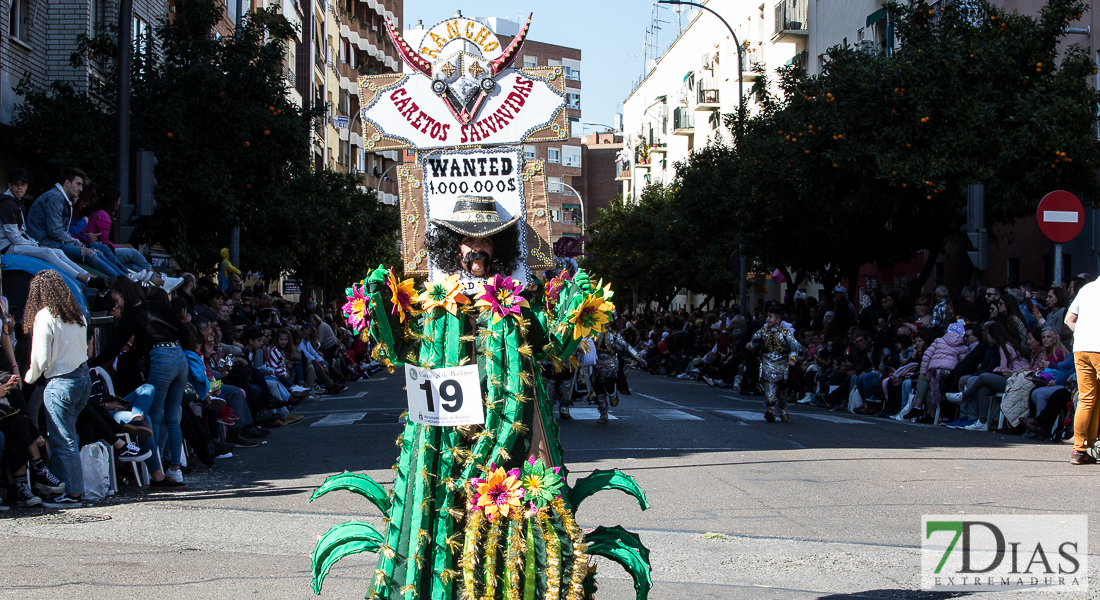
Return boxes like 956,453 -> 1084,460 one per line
0,170 -> 381,511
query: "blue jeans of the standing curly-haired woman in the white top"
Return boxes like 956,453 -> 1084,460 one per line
43,364 -> 91,495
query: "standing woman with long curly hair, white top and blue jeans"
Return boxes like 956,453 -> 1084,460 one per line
23,271 -> 91,509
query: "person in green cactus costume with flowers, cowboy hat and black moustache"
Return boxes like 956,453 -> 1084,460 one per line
312,197 -> 651,600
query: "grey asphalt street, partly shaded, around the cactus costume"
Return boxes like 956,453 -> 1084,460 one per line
0,370 -> 1100,600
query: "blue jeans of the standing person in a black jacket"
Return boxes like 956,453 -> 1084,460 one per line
147,346 -> 188,470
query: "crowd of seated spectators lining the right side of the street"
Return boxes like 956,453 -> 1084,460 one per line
617,274 -> 1091,440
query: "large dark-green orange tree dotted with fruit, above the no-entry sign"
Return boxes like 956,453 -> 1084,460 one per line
675,0 -> 1100,295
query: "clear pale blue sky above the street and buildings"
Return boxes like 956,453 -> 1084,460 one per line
403,0 -> 686,132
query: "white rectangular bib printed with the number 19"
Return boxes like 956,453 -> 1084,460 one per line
405,364 -> 485,427
